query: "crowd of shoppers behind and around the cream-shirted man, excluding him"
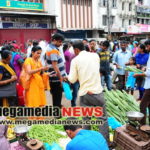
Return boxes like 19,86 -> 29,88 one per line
0,34 -> 149,120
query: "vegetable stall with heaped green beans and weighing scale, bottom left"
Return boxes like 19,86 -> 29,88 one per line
8,125 -> 70,150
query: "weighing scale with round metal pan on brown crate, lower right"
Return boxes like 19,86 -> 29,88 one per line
114,112 -> 150,150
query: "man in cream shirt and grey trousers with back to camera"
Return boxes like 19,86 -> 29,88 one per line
68,41 -> 109,140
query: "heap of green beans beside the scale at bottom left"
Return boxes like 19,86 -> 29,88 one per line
28,125 -> 65,144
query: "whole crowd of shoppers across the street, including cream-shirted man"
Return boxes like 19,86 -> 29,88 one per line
0,33 -> 150,149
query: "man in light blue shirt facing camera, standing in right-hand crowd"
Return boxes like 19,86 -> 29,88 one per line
113,41 -> 132,90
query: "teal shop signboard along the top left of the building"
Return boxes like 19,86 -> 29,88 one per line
0,0 -> 44,11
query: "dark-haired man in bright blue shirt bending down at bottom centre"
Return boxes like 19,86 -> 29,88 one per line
64,119 -> 109,150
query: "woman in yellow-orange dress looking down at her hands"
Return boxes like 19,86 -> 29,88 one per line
20,46 -> 48,107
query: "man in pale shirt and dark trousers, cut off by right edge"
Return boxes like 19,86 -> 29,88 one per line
134,40 -> 150,125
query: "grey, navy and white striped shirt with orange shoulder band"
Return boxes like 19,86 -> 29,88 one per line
46,44 -> 66,82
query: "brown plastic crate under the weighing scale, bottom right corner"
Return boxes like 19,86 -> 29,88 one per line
114,126 -> 150,150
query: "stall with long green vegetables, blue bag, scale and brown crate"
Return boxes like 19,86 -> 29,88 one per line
105,89 -> 150,150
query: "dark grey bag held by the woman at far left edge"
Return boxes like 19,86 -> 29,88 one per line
0,81 -> 17,98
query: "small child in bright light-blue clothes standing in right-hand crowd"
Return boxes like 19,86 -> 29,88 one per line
126,57 -> 136,95
